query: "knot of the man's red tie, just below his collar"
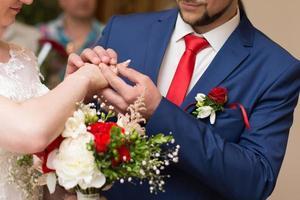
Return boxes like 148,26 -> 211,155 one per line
184,34 -> 209,54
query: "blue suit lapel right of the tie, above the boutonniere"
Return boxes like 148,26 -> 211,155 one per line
181,13 -> 254,108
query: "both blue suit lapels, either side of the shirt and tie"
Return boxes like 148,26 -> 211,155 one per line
145,9 -> 254,108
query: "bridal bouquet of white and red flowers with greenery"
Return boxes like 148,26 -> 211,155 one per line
33,97 -> 179,199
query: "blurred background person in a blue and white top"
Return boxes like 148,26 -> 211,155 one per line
40,0 -> 104,53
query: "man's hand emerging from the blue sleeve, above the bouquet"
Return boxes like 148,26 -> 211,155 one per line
100,64 -> 162,119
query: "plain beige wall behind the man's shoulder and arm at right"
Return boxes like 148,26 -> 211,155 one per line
244,0 -> 300,200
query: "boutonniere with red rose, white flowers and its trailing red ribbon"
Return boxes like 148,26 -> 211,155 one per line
185,87 -> 250,129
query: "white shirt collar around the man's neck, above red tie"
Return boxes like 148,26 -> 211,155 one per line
173,9 -> 240,52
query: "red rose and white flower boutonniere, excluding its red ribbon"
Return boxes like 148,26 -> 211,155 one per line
192,87 -> 228,124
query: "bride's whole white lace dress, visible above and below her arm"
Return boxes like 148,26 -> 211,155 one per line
0,44 -> 48,200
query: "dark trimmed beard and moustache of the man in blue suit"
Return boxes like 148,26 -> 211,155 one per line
178,0 -> 233,27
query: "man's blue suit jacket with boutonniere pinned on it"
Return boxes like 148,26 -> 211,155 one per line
98,9 -> 300,200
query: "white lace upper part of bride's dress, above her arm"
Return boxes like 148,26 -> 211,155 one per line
0,44 -> 49,101
